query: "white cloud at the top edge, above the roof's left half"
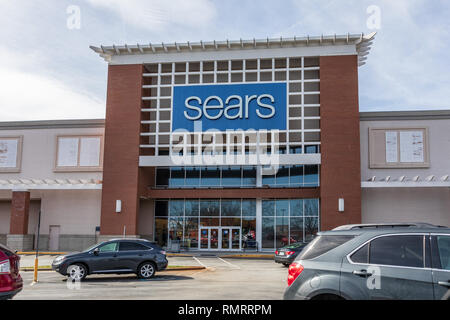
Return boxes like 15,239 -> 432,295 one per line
87,0 -> 216,31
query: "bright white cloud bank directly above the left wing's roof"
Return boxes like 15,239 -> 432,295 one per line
0,50 -> 105,121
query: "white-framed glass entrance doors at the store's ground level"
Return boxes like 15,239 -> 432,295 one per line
199,227 -> 241,250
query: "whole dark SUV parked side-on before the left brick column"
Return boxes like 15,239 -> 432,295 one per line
52,239 -> 168,280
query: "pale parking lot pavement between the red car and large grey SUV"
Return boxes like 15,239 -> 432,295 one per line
15,256 -> 287,300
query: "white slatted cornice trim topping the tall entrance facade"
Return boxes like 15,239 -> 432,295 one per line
90,32 -> 376,66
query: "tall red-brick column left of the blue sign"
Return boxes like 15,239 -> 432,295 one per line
100,65 -> 143,238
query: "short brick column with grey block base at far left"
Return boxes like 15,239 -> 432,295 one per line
6,191 -> 33,251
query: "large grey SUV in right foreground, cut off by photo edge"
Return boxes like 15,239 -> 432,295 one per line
284,223 -> 450,300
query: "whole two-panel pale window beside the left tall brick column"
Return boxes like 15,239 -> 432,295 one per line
55,136 -> 103,171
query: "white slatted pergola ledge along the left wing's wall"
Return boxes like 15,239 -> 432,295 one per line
0,179 -> 102,191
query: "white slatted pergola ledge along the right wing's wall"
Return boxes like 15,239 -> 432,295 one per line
361,174 -> 450,188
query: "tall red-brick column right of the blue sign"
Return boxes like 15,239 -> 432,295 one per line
320,55 -> 361,230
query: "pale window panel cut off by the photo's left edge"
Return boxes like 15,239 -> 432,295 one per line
0,136 -> 23,173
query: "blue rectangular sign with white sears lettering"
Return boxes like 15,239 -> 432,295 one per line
172,83 -> 287,132
